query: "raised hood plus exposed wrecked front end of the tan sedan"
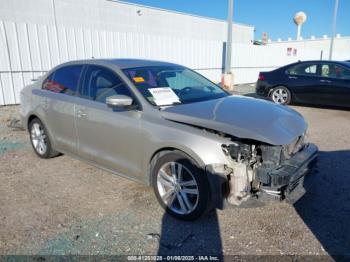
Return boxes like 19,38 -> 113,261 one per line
161,96 -> 318,208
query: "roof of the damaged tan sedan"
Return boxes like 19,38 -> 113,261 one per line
59,58 -> 182,69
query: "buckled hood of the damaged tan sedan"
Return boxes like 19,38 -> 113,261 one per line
161,96 -> 307,145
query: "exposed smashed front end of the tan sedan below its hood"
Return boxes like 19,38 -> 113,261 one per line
206,134 -> 318,208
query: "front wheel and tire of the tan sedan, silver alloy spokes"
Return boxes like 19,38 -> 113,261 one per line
151,152 -> 210,220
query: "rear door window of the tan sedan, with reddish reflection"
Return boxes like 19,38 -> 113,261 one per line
43,65 -> 83,95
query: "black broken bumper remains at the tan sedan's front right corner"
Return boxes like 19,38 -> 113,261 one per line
257,144 -> 318,203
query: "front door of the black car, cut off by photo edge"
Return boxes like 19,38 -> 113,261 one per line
319,63 -> 350,106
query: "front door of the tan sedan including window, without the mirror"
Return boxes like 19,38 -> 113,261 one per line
76,65 -> 143,178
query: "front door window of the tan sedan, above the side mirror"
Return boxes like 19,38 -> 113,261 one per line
81,65 -> 133,103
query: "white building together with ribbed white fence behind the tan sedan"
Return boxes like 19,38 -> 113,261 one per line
0,0 -> 254,105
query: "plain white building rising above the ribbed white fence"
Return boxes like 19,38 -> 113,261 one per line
0,0 -> 254,43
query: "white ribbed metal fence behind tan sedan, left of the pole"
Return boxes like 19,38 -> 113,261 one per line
0,21 -> 227,105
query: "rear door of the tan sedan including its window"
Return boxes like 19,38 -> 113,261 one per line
42,65 -> 83,153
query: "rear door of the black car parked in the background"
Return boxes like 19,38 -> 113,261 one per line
286,63 -> 321,104
